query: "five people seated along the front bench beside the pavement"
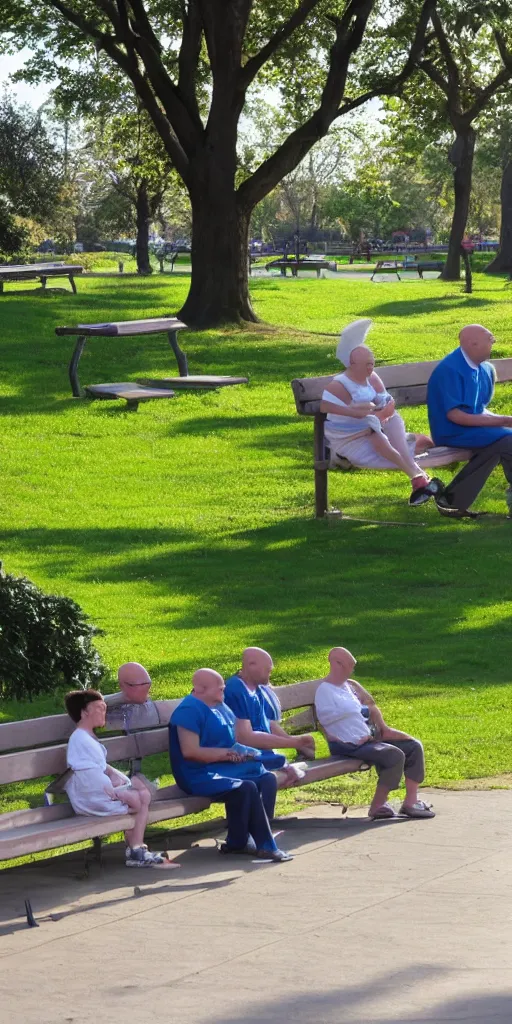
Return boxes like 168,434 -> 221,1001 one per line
66,647 -> 434,867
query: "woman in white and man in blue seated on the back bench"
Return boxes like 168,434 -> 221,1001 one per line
321,319 -> 512,519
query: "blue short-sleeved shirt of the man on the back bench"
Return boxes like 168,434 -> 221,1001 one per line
427,348 -> 512,449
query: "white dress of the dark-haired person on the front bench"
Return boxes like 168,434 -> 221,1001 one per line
66,729 -> 131,815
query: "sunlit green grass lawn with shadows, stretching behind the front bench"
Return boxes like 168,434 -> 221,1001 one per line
0,274 -> 512,835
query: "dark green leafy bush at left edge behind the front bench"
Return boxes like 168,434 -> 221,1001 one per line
0,563 -> 106,700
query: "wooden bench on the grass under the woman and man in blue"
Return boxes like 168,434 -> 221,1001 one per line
292,358 -> 512,519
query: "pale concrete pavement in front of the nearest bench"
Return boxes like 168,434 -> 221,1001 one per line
0,791 -> 512,1024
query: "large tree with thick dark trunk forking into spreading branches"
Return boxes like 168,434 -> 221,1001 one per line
0,0 -> 435,324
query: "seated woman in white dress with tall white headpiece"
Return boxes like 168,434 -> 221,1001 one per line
321,319 -> 439,505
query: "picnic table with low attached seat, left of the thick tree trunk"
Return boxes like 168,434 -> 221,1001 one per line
55,316 -> 248,411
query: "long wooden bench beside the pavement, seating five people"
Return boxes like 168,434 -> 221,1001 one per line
0,680 -> 368,861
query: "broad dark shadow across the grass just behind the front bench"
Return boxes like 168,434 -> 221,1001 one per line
4,518 -> 512,695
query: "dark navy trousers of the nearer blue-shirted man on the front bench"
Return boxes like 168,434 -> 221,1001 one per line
215,772 -> 278,850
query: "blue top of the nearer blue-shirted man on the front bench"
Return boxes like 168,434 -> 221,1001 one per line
169,693 -> 265,797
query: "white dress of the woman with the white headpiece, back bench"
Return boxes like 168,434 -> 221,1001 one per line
322,374 -> 416,469
